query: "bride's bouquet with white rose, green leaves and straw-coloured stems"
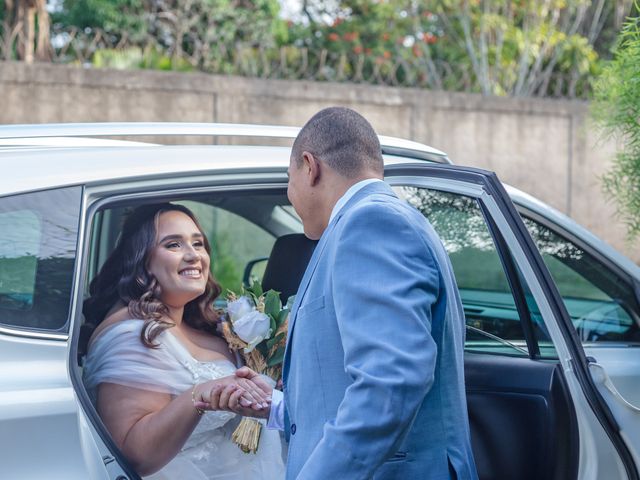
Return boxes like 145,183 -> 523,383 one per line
222,282 -> 293,453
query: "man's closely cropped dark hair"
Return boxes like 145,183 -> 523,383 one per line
291,107 -> 384,178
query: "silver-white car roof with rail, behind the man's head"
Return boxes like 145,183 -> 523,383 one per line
0,123 -> 451,195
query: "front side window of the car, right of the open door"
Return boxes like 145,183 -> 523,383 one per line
523,218 -> 640,343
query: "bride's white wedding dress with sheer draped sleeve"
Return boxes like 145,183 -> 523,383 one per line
84,319 -> 285,480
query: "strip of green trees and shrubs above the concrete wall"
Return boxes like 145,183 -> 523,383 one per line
23,0 -> 630,97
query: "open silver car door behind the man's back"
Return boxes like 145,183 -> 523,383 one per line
386,164 -> 637,478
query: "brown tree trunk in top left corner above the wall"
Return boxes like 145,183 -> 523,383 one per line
2,0 -> 51,63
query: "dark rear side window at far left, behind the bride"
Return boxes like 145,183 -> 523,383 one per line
0,187 -> 81,331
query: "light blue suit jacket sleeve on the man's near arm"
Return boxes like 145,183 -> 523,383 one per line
298,203 -> 440,479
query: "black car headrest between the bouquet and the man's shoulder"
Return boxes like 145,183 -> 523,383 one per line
262,233 -> 318,304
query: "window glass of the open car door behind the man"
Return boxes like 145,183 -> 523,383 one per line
396,187 -> 528,355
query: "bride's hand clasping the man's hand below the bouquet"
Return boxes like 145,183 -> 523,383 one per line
194,375 -> 271,410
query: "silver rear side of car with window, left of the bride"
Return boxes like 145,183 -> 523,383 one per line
0,186 -> 113,479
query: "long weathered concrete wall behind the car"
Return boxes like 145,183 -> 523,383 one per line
0,62 -> 640,262
